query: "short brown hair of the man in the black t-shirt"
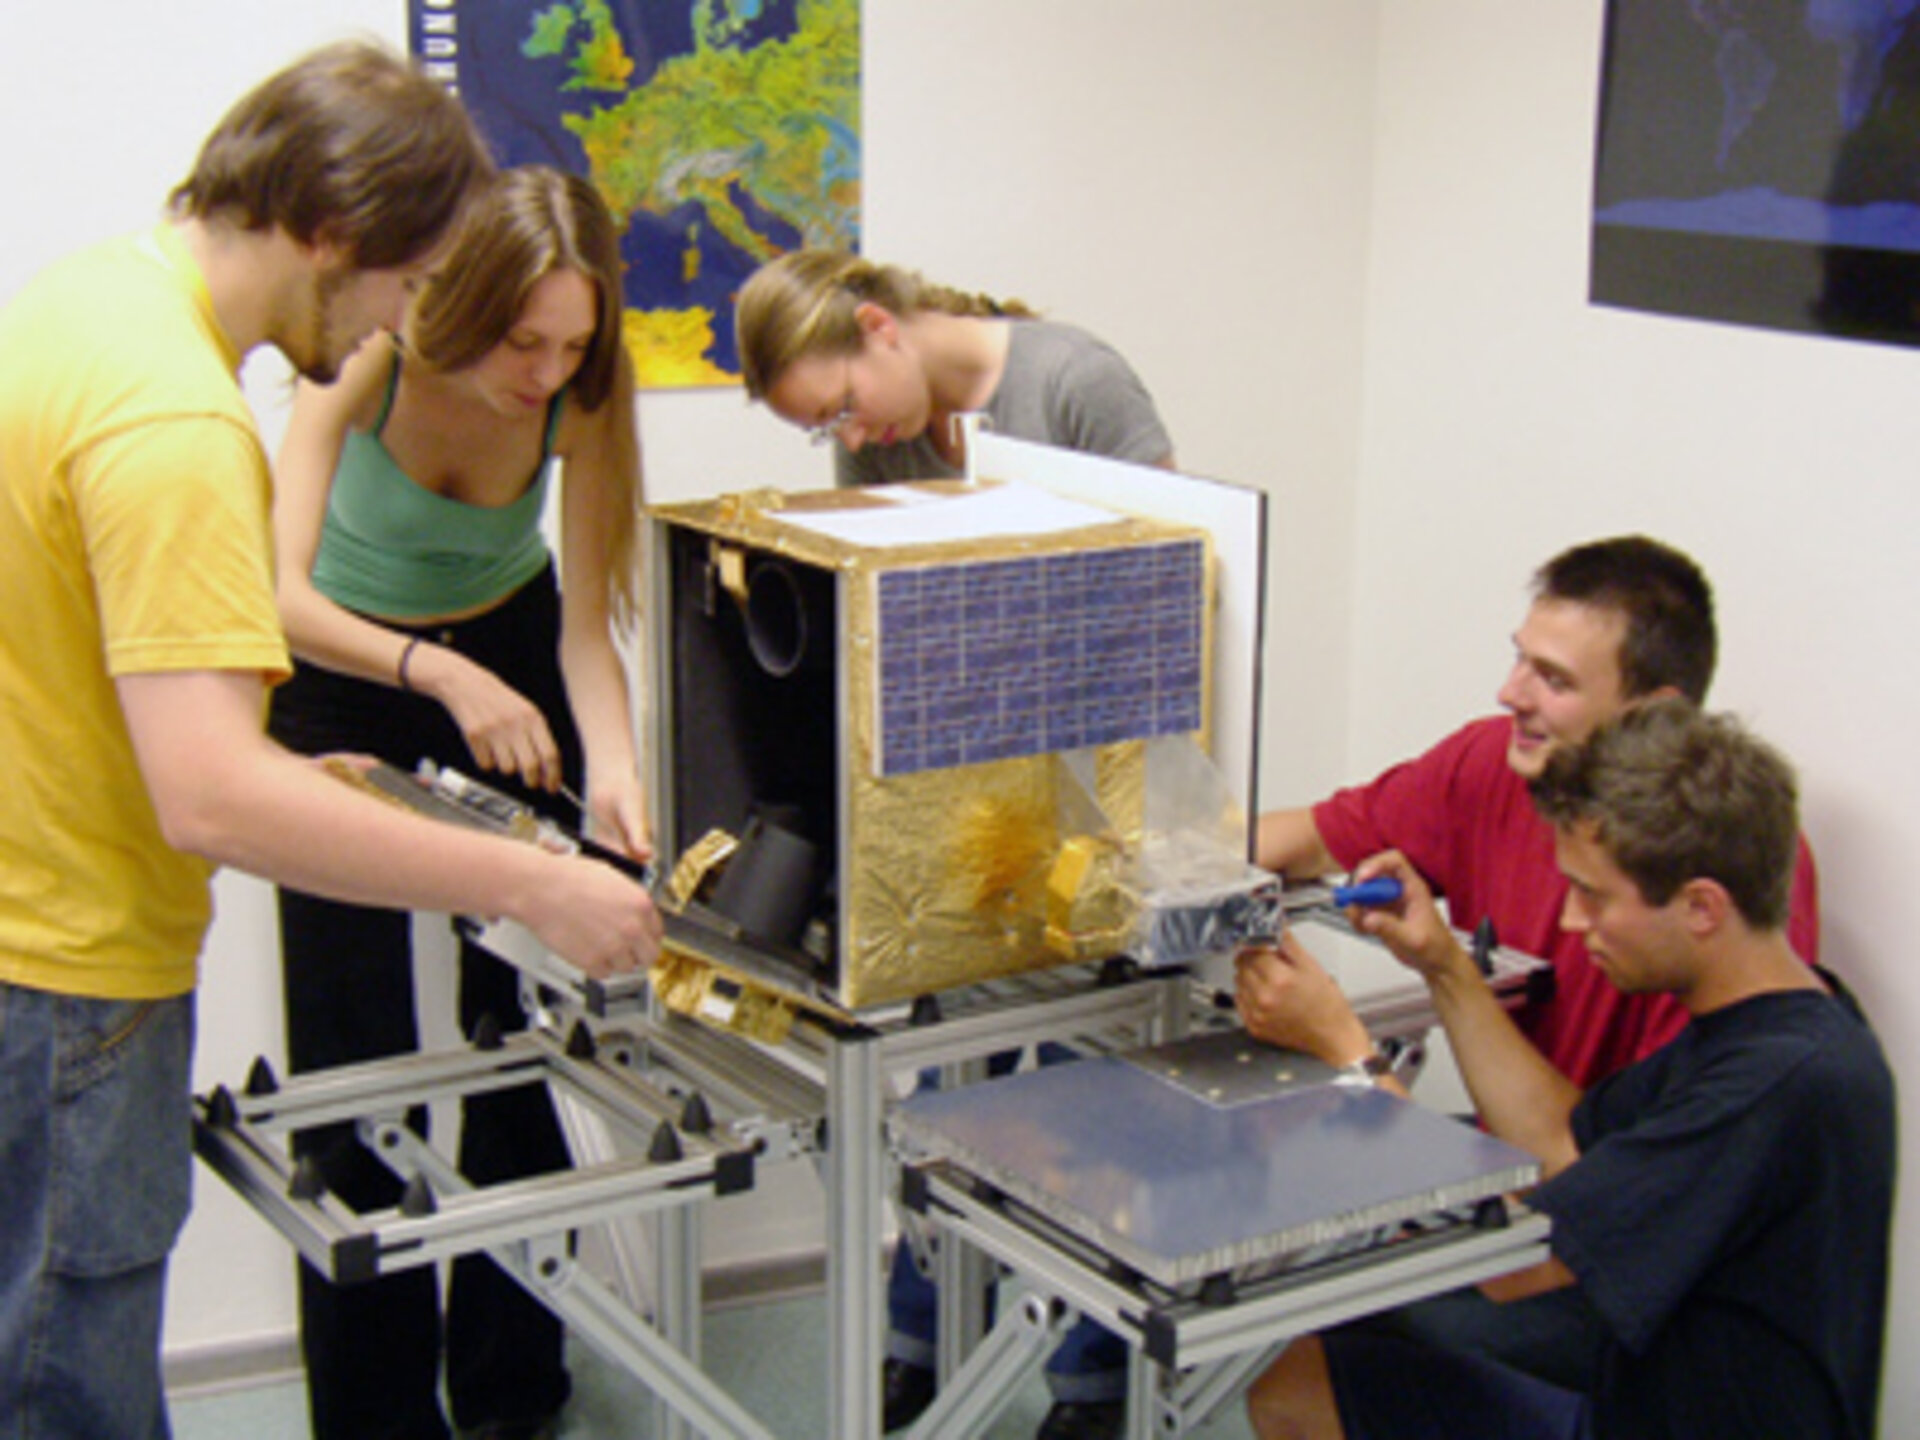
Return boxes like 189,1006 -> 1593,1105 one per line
1530,697 -> 1799,929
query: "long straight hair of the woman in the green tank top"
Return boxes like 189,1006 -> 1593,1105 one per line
407,165 -> 645,630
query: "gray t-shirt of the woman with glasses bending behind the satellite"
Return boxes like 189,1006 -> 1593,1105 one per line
833,321 -> 1173,486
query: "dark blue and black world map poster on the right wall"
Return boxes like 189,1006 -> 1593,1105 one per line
1590,0 -> 1920,346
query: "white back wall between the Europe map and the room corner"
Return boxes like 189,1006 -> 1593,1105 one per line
866,0 -> 1375,814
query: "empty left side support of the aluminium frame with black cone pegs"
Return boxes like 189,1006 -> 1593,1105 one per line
194,1029 -> 791,1440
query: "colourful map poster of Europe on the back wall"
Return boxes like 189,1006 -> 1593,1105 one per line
407,0 -> 860,390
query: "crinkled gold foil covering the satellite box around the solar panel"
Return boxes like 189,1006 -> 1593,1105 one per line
651,482 -> 1212,1010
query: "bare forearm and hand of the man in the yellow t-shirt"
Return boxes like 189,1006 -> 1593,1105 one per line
117,670 -> 660,975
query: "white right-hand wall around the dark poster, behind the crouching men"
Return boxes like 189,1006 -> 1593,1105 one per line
1348,0 -> 1920,1434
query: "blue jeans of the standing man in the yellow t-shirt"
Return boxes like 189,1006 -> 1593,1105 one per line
0,985 -> 194,1440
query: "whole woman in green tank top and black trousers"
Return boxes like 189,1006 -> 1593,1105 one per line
271,167 -> 651,1440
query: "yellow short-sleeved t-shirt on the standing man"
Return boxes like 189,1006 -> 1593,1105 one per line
0,227 -> 288,998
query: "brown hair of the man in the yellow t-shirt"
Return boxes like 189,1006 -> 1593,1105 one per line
169,40 -> 493,271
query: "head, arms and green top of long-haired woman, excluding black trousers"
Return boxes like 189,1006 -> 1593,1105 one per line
275,167 -> 647,854
